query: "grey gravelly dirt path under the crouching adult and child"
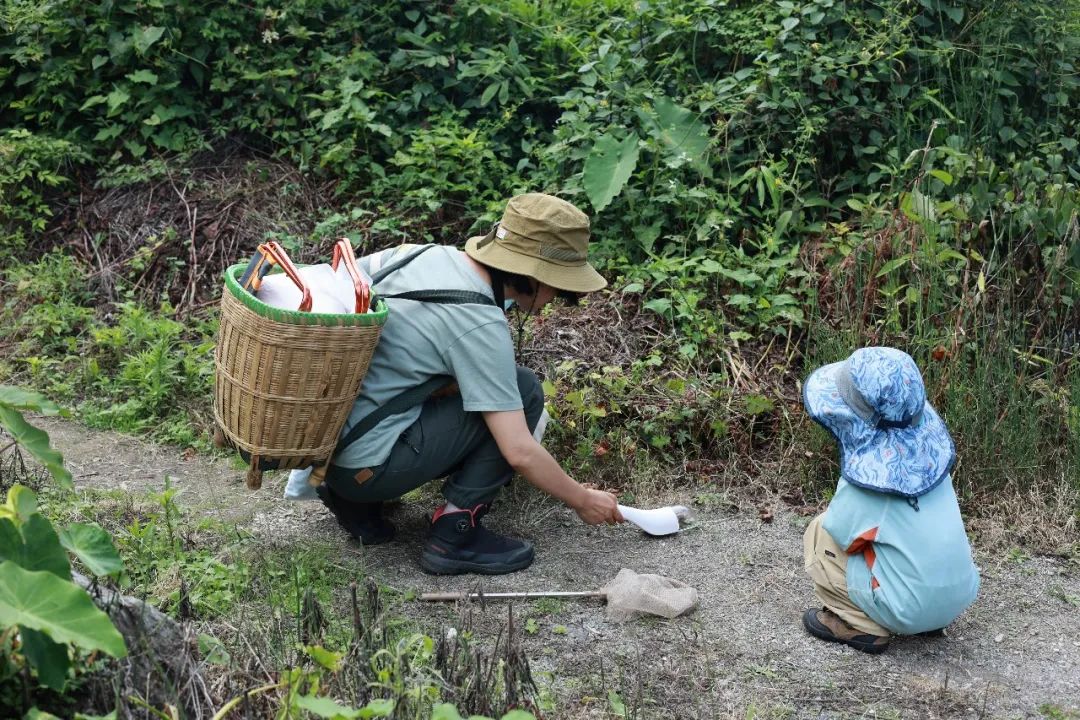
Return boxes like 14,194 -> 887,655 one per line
39,419 -> 1080,719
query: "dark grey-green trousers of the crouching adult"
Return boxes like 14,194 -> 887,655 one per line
317,367 -> 543,507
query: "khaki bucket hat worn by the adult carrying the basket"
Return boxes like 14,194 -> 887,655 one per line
465,192 -> 607,293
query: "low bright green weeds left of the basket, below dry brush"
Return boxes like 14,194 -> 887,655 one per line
0,253 -> 214,445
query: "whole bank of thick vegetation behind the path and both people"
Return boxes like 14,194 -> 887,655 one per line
0,0 -> 1080,716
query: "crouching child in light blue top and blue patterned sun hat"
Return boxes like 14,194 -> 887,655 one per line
802,348 -> 978,653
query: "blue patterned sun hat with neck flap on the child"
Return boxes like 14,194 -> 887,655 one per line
802,348 -> 956,498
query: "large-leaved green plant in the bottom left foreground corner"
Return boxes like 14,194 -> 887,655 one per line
0,385 -> 127,708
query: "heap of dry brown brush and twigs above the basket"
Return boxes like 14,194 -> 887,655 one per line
46,148 -> 330,311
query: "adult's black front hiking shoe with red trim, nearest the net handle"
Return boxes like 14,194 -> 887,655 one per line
420,503 -> 534,575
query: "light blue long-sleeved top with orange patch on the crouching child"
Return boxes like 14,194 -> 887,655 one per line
824,477 -> 978,635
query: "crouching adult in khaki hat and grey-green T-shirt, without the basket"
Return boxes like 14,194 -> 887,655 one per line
308,193 -> 622,574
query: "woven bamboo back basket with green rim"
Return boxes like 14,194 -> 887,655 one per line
214,264 -> 388,489
